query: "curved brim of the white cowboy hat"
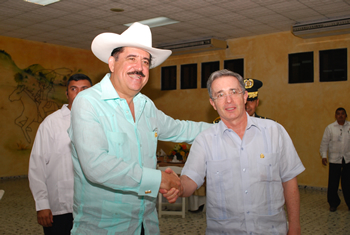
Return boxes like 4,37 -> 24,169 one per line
91,33 -> 172,69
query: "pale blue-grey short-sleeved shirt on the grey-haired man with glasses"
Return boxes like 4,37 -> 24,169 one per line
182,114 -> 305,235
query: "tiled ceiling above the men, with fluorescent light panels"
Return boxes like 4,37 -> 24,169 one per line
0,0 -> 350,50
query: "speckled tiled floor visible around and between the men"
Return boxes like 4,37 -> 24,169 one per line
0,178 -> 350,235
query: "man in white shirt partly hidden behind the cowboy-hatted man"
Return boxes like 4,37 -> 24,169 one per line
28,74 -> 92,235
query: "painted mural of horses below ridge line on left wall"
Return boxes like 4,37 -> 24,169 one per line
0,50 -> 81,169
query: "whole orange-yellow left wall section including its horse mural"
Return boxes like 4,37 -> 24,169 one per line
0,35 -> 109,179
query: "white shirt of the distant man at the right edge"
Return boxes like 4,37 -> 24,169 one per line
320,121 -> 350,164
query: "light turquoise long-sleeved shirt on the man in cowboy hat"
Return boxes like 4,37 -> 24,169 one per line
68,74 -> 211,235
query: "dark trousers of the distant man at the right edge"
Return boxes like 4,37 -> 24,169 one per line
327,159 -> 350,209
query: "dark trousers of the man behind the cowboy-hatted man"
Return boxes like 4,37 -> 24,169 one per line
43,213 -> 73,235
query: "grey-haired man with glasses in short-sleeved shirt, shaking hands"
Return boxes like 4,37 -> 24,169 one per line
163,70 -> 305,235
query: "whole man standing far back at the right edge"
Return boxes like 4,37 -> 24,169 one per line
320,108 -> 350,212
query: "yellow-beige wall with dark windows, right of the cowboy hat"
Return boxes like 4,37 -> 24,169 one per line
144,32 -> 350,187
